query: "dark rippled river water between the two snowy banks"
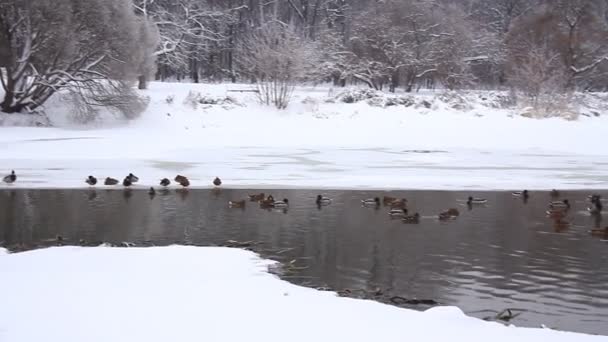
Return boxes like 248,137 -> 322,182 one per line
0,189 -> 608,334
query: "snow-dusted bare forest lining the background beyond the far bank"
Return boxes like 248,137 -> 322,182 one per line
0,0 -> 608,113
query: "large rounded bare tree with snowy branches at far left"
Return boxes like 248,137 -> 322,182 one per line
0,0 -> 156,113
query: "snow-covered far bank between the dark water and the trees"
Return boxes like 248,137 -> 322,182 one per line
0,83 -> 608,190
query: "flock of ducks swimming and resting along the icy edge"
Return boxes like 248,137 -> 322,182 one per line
2,170 -> 608,238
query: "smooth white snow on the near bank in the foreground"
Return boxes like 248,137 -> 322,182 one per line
0,246 -> 608,342
